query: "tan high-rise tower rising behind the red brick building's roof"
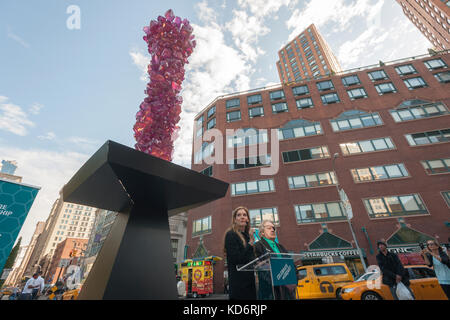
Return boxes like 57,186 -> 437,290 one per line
277,24 -> 341,83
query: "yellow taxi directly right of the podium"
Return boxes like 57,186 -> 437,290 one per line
296,263 -> 353,299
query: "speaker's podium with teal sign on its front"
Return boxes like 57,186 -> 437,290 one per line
236,252 -> 303,299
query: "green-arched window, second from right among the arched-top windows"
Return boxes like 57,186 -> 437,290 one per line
330,110 -> 383,132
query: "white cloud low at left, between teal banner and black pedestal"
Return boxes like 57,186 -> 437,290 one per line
0,144 -> 89,244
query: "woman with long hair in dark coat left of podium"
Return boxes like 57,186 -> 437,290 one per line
224,207 -> 256,300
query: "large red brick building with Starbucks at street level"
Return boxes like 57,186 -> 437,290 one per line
187,51 -> 450,292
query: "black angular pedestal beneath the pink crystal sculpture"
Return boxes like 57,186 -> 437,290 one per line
62,141 -> 228,299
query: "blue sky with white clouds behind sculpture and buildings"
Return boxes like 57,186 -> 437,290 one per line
0,0 -> 431,244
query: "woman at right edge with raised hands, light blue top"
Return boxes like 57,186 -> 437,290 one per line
422,239 -> 450,300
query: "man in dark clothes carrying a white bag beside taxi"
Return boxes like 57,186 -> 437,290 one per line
377,241 -> 415,300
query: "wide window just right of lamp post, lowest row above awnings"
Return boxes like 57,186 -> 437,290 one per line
364,194 -> 428,218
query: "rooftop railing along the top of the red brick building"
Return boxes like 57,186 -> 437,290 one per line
195,49 -> 450,118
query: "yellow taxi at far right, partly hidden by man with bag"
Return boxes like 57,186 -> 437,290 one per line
341,265 -> 447,300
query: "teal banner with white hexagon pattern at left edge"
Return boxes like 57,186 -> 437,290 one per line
0,179 -> 40,274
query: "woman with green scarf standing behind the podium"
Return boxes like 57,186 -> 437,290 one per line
255,220 -> 293,300
